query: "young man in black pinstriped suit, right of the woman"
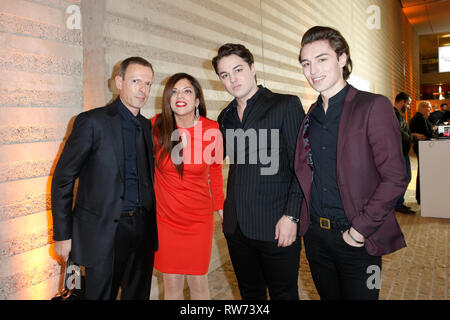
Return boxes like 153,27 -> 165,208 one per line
212,44 -> 305,300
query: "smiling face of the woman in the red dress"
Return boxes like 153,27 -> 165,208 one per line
169,79 -> 200,117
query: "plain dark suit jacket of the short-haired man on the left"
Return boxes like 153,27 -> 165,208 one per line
51,98 -> 157,267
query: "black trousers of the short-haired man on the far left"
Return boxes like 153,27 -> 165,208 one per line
85,209 -> 154,300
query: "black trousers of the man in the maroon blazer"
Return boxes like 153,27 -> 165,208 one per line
303,223 -> 381,300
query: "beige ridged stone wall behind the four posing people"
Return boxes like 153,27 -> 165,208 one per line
0,0 -> 419,299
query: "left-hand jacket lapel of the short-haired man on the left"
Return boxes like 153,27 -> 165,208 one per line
107,98 -> 125,181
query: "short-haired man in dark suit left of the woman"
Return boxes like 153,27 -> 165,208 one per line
51,57 -> 158,300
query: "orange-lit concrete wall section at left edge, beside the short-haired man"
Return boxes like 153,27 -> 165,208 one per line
0,0 -> 83,299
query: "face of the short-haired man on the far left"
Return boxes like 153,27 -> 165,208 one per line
115,64 -> 153,115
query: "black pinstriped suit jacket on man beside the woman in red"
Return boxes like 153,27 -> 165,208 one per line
218,87 -> 305,241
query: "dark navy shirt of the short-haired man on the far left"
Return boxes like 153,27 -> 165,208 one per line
118,101 -> 140,211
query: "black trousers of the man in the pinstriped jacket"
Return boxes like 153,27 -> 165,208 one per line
225,226 -> 301,300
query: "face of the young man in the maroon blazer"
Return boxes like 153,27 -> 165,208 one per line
300,40 -> 347,97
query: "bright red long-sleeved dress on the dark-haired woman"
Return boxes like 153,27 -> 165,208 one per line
151,117 -> 224,275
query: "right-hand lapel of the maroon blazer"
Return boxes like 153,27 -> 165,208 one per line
336,85 -> 358,168
